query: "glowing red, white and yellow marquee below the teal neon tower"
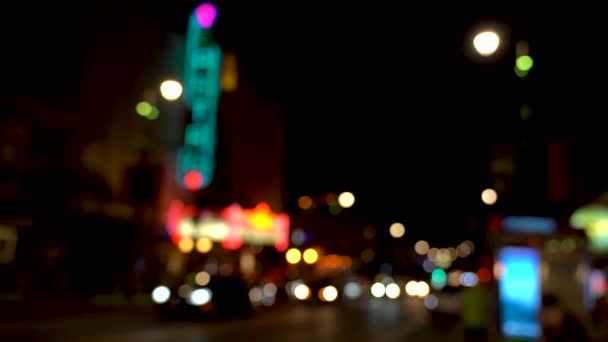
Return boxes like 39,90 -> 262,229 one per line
167,200 -> 289,252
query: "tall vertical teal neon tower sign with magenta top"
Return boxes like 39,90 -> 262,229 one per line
176,3 -> 222,190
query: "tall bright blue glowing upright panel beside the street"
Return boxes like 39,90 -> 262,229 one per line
498,247 -> 542,340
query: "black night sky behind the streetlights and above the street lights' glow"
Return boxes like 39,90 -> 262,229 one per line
5,1 -> 608,235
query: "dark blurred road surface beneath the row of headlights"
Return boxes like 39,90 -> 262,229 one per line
0,298 -> 428,342
